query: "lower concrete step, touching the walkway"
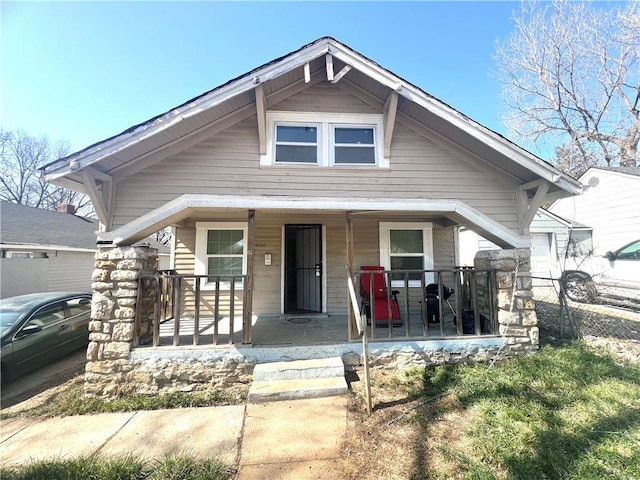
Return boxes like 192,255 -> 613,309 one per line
248,376 -> 349,403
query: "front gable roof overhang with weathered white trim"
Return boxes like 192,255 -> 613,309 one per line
41,37 -> 580,200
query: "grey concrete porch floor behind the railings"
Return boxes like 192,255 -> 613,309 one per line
151,312 -> 480,347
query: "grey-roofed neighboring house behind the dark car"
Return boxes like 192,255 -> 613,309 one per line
0,201 -> 169,298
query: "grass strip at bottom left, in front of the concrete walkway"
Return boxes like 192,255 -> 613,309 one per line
0,456 -> 235,480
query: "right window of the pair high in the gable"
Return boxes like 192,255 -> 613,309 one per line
333,125 -> 376,165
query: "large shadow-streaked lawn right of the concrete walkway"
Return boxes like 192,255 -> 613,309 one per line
345,341 -> 640,479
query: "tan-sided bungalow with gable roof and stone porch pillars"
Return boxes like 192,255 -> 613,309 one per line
37,38 -> 580,396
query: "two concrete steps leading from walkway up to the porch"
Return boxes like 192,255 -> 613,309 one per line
248,357 -> 349,402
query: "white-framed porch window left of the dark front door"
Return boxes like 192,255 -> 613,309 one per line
194,222 -> 247,288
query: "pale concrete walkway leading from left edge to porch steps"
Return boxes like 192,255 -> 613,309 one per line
0,396 -> 347,480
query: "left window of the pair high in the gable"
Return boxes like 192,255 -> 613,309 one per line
275,124 -> 318,163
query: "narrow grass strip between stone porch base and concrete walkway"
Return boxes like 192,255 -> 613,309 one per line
0,384 -> 247,420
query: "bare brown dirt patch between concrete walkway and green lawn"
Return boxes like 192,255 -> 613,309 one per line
343,369 -> 473,480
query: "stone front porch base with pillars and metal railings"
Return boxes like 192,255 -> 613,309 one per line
85,240 -> 538,396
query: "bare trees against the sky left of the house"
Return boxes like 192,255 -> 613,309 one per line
0,128 -> 94,216
